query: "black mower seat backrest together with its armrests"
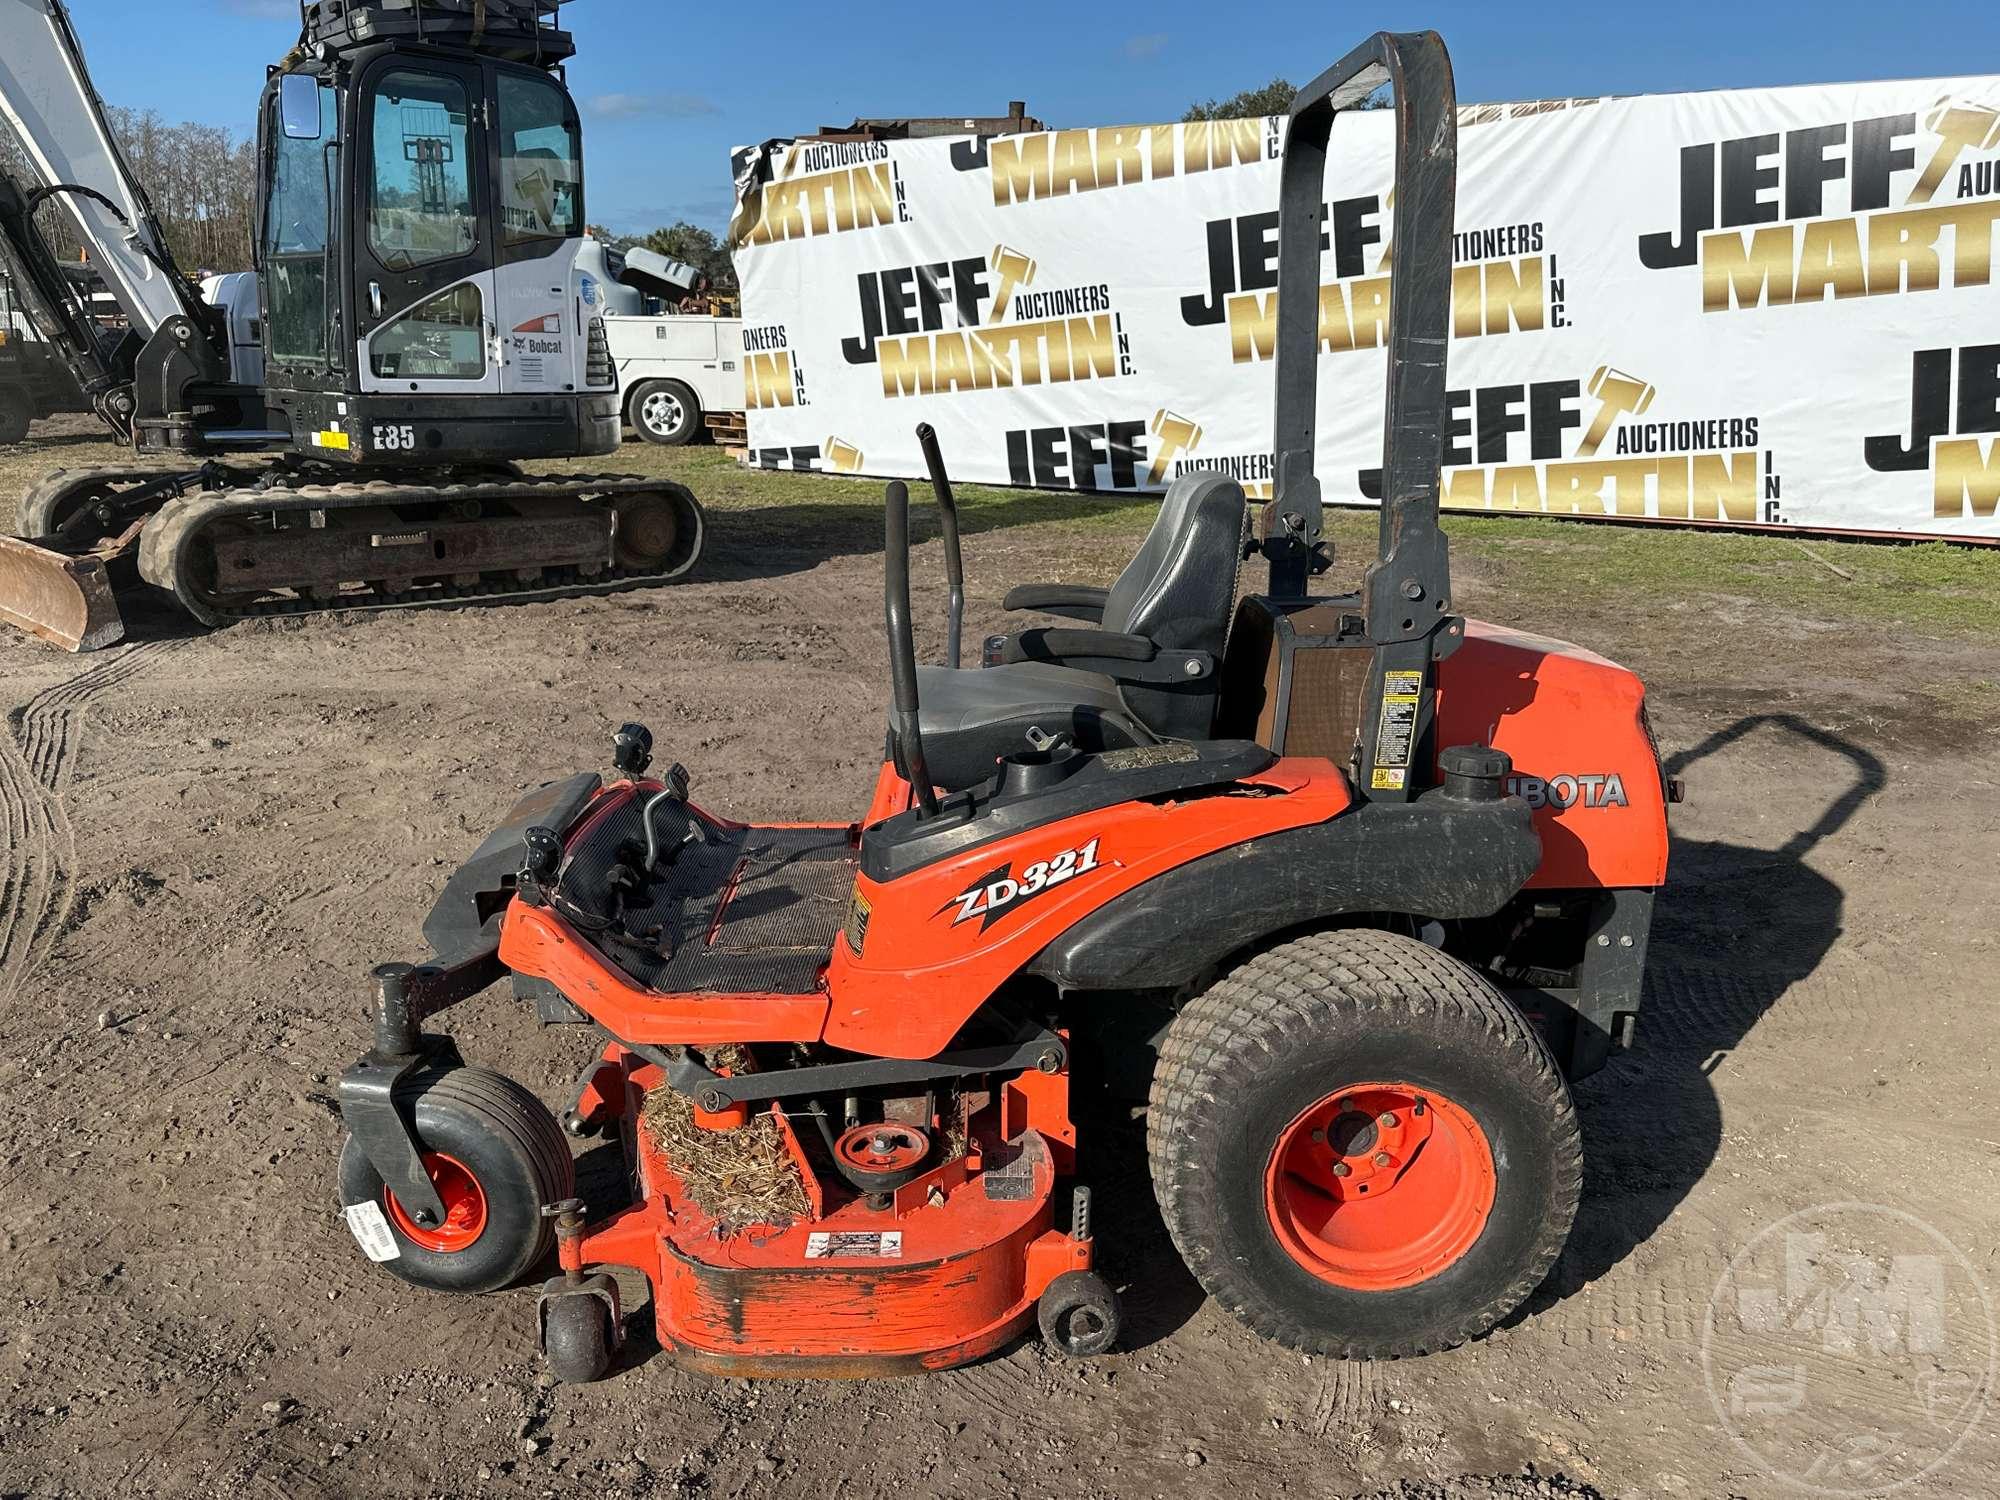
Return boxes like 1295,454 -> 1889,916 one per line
986,472 -> 1244,740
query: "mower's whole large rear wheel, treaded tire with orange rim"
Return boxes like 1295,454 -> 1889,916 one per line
1146,930 -> 1582,1358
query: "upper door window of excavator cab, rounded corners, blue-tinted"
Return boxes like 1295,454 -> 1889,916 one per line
368,68 -> 480,270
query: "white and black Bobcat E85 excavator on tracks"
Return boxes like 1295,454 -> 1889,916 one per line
0,0 -> 704,650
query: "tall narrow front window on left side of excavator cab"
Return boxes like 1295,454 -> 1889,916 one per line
262,74 -> 338,366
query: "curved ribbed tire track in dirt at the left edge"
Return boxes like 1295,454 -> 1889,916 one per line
0,642 -> 166,1004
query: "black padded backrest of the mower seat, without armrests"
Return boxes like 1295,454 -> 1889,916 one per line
1104,472 -> 1244,656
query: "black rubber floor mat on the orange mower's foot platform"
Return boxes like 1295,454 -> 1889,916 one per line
562,798 -> 854,994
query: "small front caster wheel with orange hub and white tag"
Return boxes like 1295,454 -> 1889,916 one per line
340,1068 -> 576,1292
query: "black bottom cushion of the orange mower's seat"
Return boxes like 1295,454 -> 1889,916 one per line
916,662 -> 1156,792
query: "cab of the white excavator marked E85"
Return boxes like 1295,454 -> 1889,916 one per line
258,0 -> 620,466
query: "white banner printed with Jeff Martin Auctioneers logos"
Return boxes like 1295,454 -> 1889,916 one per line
734,76 -> 2000,540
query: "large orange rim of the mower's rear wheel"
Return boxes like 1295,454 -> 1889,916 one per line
1264,1084 -> 1494,1292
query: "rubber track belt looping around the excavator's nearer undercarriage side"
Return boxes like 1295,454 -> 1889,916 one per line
140,474 -> 708,626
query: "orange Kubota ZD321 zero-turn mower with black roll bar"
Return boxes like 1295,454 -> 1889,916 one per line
340,32 -> 1666,1380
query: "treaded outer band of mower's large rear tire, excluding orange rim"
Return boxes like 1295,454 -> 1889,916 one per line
1146,928 -> 1584,1360
